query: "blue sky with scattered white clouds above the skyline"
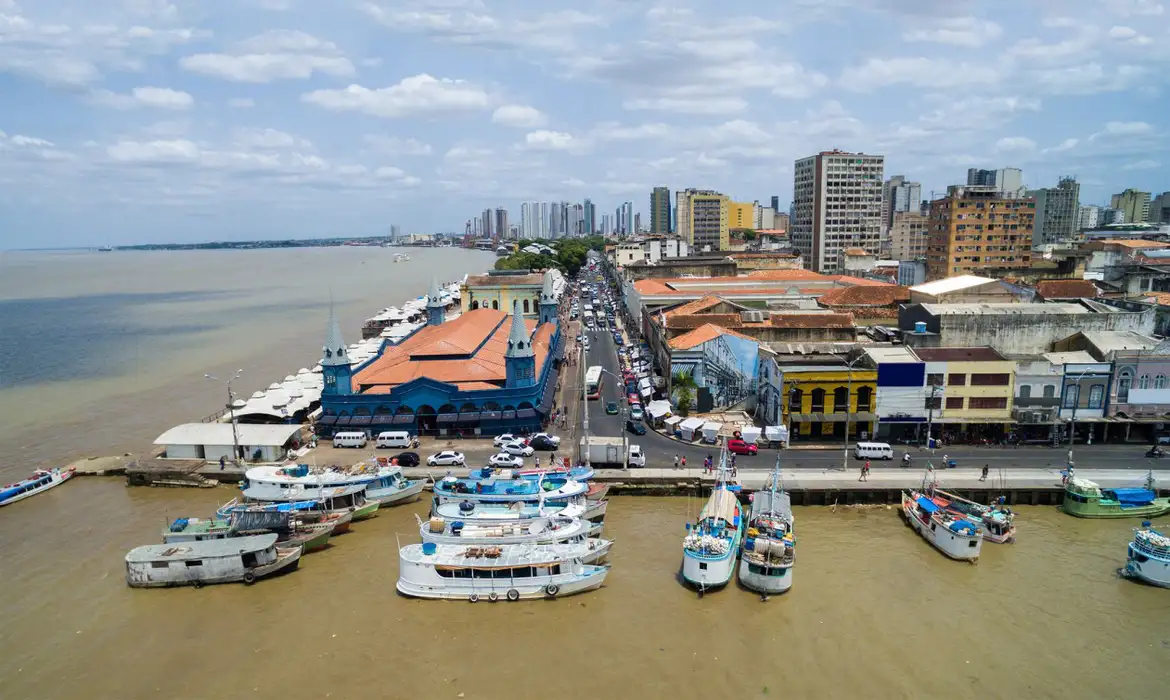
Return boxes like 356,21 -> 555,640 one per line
0,0 -> 1170,249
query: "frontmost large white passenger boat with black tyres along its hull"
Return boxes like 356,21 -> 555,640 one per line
395,542 -> 610,603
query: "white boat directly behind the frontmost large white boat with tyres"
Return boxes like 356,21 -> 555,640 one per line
415,515 -> 613,564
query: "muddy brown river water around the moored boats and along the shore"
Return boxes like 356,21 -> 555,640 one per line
0,249 -> 1170,700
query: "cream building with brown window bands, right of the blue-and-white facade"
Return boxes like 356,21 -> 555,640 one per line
914,348 -> 1016,438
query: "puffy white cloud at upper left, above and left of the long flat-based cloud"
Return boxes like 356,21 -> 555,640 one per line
179,29 -> 356,83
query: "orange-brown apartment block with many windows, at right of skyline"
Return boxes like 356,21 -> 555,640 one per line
927,185 -> 1035,280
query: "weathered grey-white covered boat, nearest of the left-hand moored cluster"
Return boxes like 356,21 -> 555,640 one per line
126,533 -> 302,588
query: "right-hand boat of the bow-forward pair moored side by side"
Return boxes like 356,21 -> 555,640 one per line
739,457 -> 796,596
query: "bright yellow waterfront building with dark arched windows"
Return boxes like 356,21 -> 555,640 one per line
778,363 -> 878,440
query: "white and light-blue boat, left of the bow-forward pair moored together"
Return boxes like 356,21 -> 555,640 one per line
682,447 -> 744,592
